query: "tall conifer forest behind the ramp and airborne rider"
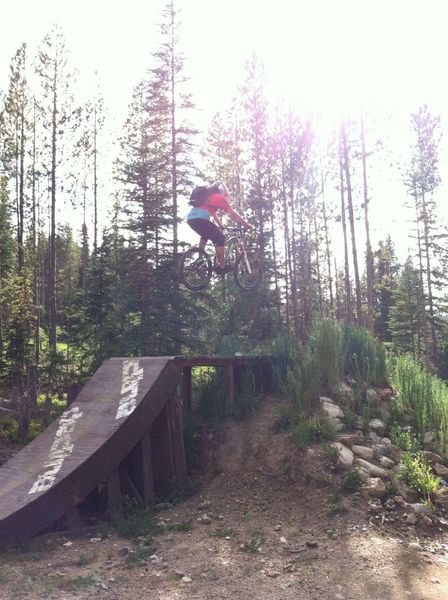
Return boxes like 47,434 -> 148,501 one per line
0,0 -> 448,435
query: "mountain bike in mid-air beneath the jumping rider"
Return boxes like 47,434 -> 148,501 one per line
179,227 -> 262,292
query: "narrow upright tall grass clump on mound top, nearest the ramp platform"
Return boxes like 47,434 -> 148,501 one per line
310,319 -> 342,393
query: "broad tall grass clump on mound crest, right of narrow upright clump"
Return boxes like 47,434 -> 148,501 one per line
342,324 -> 387,386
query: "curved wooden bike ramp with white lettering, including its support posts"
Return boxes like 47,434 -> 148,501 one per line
0,357 -> 186,544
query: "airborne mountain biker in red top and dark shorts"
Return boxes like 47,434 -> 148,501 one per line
187,182 -> 252,275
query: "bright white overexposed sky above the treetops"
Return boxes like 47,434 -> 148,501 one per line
0,0 -> 448,255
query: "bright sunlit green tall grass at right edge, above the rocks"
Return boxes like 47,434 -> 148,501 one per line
390,354 -> 448,455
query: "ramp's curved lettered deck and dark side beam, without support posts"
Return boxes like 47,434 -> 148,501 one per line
0,358 -> 180,541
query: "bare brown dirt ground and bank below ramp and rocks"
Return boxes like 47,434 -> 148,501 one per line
0,397 -> 448,600
